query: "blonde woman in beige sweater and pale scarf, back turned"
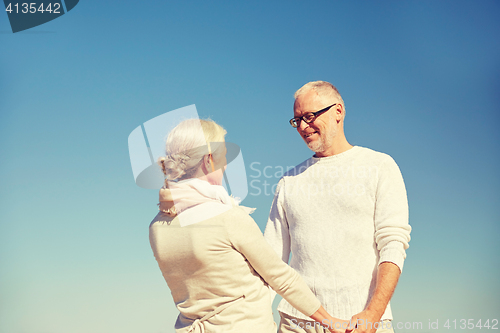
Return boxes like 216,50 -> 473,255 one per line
149,119 -> 345,333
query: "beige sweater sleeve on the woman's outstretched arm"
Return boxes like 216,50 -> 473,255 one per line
227,209 -> 321,317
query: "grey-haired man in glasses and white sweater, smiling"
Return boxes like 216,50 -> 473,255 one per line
265,81 -> 411,333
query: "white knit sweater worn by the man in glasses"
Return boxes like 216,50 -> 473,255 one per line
265,146 -> 411,320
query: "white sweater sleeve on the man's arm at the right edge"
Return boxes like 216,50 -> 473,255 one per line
375,156 -> 411,271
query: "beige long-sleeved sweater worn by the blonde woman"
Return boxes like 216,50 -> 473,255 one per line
149,204 -> 320,333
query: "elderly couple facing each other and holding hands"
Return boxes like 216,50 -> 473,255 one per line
150,81 -> 411,333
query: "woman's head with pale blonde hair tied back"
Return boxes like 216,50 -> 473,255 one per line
158,119 -> 226,180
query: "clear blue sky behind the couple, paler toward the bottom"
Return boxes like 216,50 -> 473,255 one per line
0,0 -> 500,333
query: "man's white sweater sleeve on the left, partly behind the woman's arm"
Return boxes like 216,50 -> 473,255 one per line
264,178 -> 290,263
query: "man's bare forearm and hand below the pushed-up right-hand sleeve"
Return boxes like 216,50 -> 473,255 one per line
346,262 -> 401,333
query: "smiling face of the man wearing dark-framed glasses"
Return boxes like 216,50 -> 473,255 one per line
293,90 -> 338,157
